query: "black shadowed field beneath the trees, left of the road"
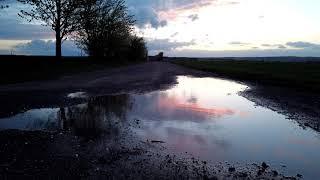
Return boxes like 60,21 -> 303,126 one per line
0,56 -> 142,84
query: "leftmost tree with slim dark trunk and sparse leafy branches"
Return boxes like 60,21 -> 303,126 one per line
18,0 -> 78,57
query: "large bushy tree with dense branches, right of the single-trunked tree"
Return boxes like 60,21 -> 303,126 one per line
75,0 -> 135,58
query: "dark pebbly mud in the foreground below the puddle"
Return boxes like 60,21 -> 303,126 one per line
0,130 -> 296,179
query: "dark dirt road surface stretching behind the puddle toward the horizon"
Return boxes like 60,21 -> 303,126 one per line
0,62 -> 209,93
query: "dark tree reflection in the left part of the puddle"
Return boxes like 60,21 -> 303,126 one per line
58,94 -> 132,138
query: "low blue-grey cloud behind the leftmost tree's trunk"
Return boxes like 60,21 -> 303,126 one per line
14,40 -> 81,56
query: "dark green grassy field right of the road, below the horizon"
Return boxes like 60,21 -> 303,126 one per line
172,60 -> 320,91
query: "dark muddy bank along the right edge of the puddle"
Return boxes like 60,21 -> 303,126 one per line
240,85 -> 320,132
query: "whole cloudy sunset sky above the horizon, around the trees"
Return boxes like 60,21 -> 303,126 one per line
0,0 -> 320,57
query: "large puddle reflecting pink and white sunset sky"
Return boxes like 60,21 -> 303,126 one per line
0,77 -> 320,179
